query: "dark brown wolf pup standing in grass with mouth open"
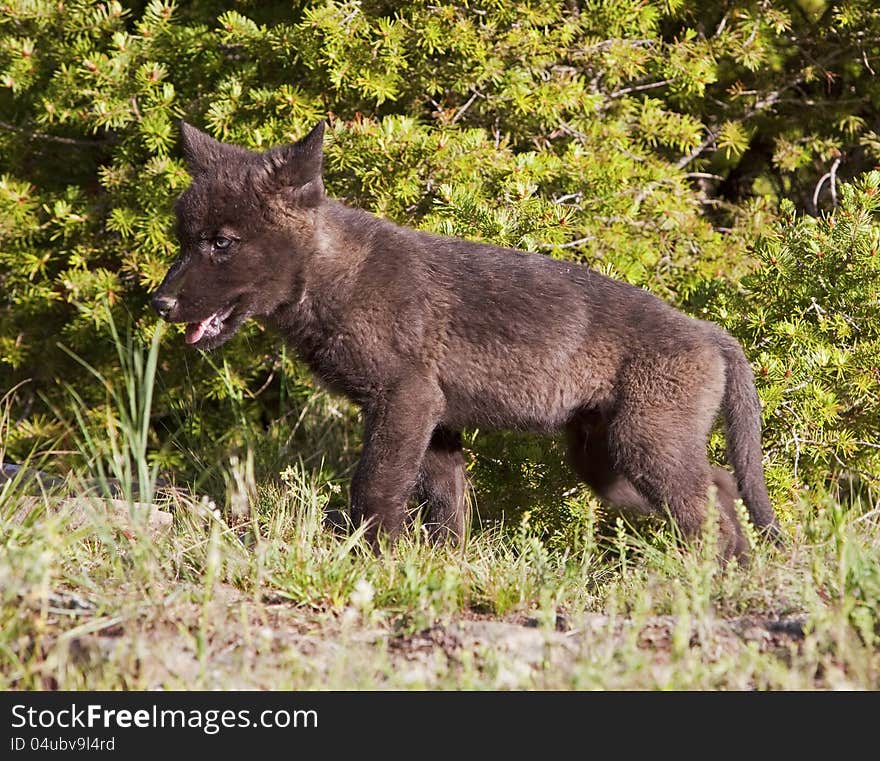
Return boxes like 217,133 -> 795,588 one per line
152,122 -> 778,559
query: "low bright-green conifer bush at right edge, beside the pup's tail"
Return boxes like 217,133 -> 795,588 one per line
709,171 -> 880,502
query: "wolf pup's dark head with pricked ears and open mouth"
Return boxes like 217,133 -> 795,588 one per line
152,121 -> 324,349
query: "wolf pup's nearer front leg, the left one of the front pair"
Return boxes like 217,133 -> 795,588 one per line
351,374 -> 444,550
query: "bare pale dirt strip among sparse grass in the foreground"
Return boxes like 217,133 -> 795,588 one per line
36,586 -> 805,690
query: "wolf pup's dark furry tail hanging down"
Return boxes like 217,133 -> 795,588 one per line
717,331 -> 782,541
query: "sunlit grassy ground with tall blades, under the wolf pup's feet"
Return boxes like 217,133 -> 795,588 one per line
0,320 -> 880,690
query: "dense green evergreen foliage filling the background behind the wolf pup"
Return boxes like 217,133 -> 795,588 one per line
0,0 -> 880,530
